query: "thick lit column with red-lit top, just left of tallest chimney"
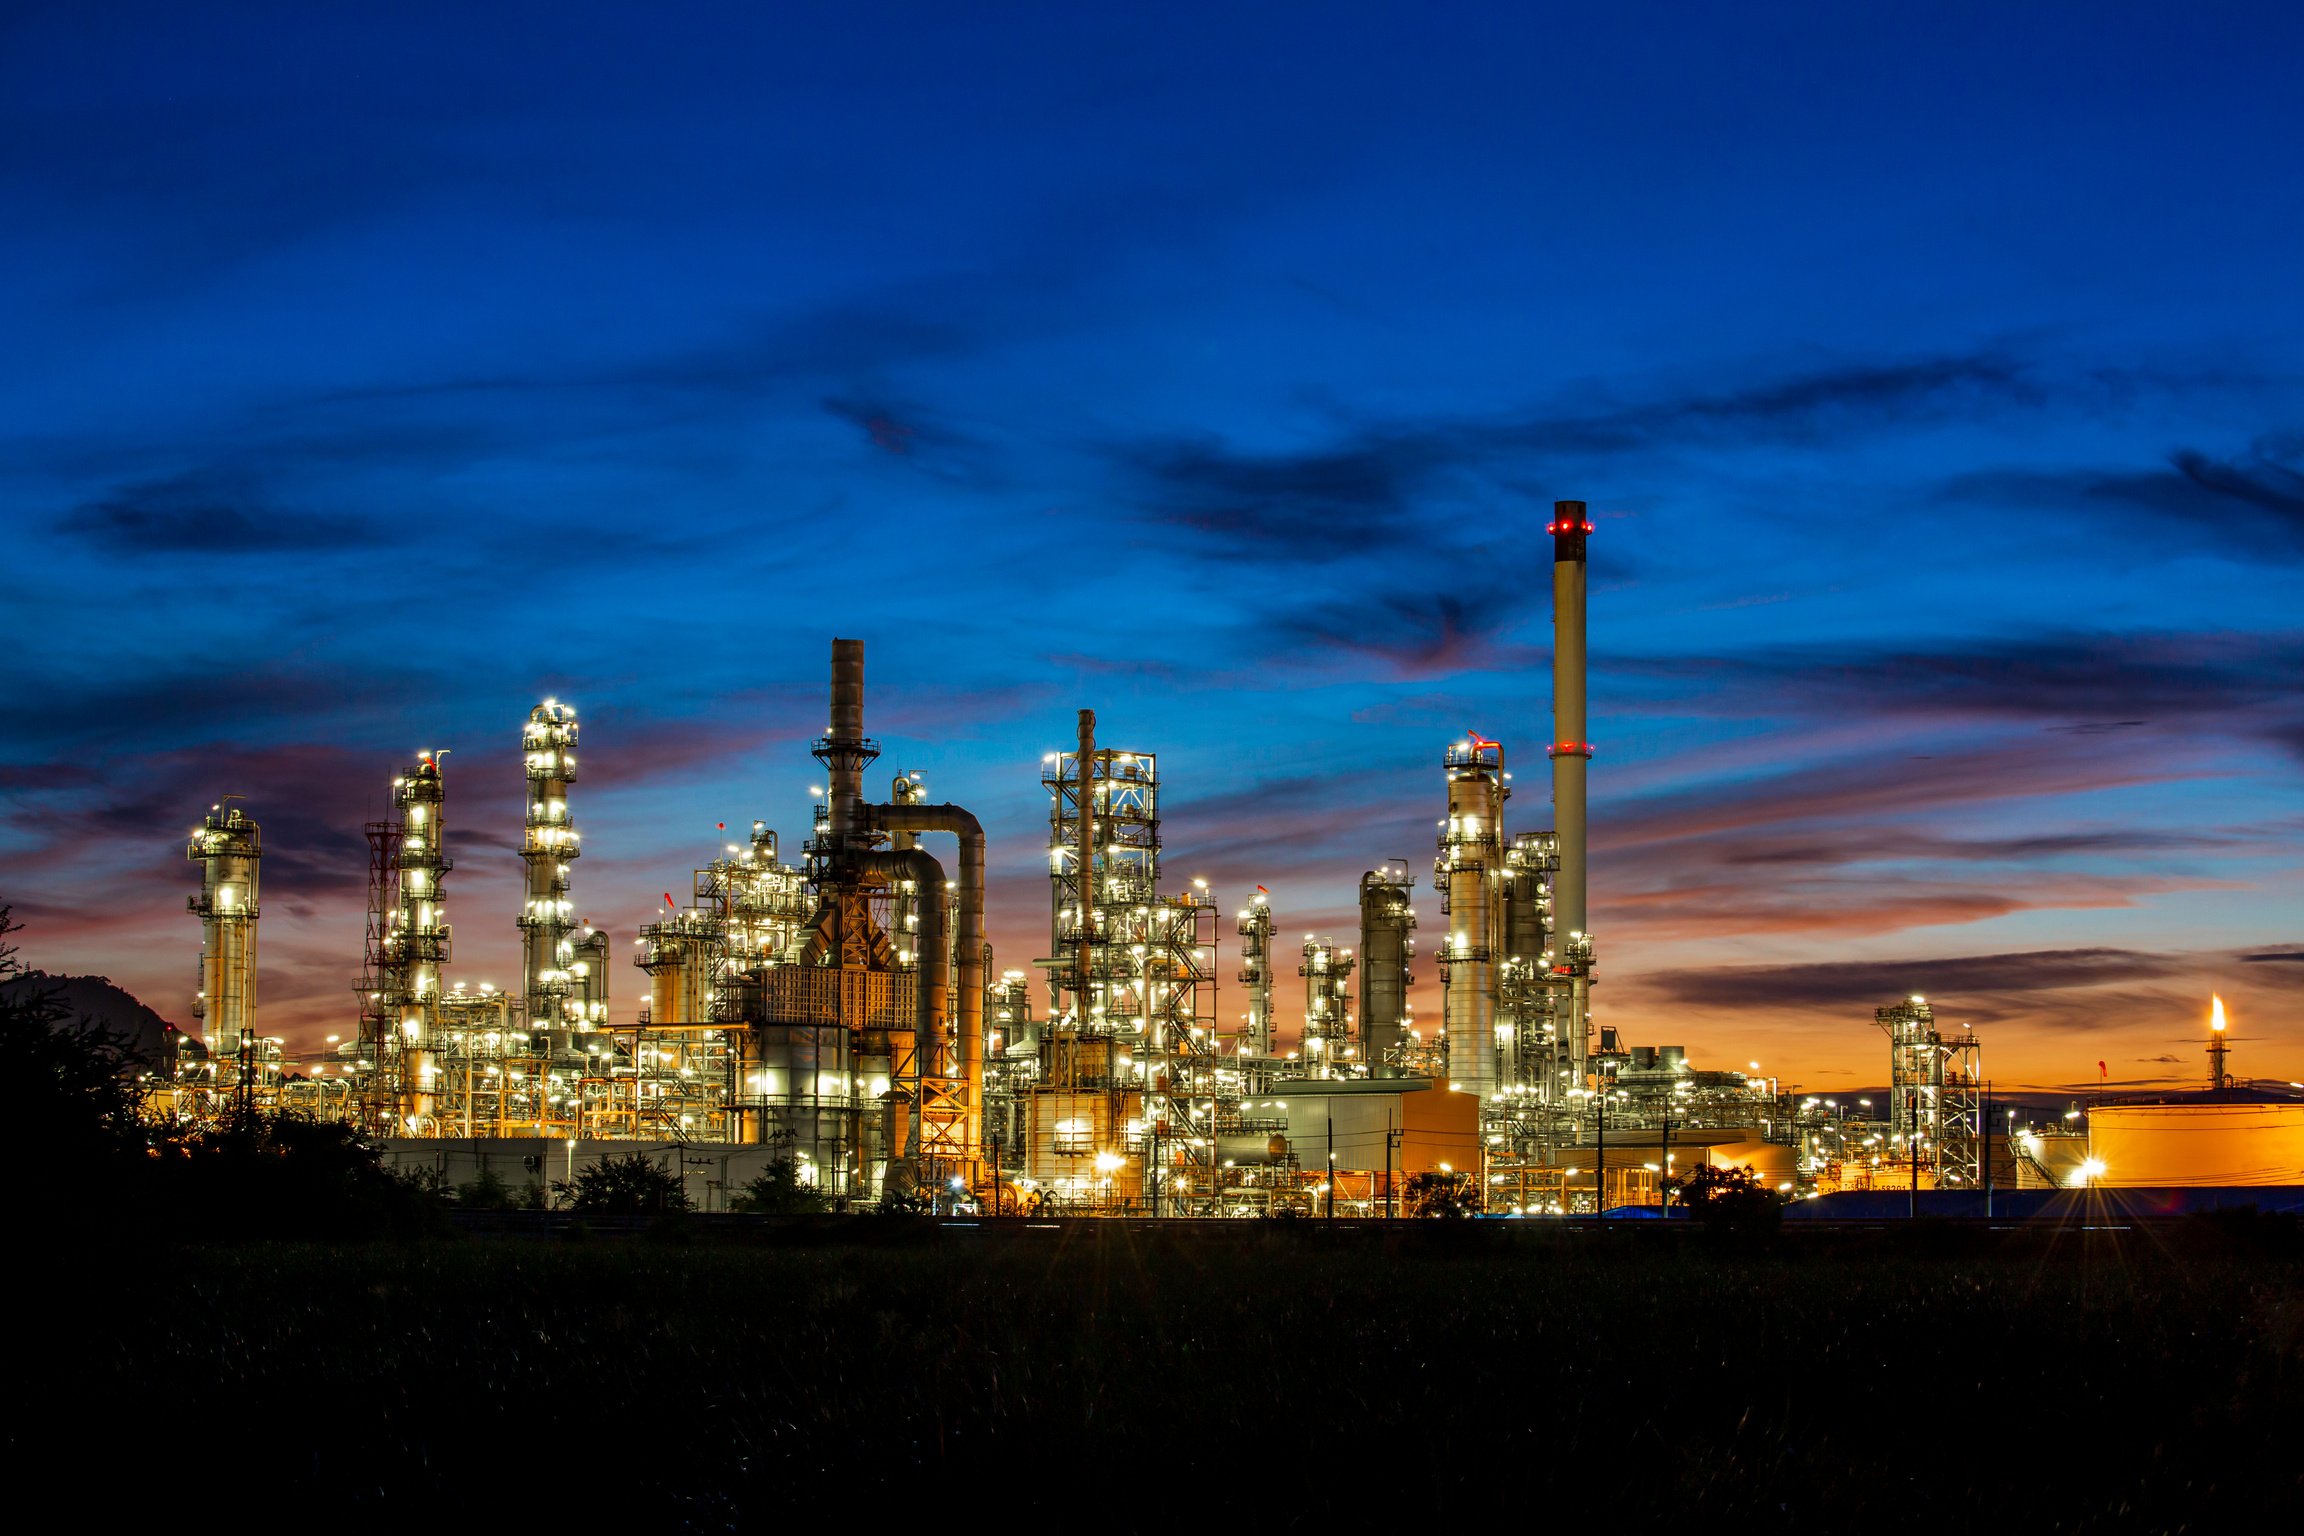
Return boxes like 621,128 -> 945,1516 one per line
1433,732 -> 1507,1101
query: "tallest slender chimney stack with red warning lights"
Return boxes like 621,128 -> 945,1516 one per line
1548,502 -> 1592,1082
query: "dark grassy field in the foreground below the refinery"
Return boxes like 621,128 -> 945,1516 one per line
31,1221 -> 2304,1531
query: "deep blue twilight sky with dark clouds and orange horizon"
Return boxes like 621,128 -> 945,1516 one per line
0,0 -> 2304,1089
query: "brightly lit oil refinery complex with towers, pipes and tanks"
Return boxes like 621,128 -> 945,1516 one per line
152,502 -> 2304,1218
